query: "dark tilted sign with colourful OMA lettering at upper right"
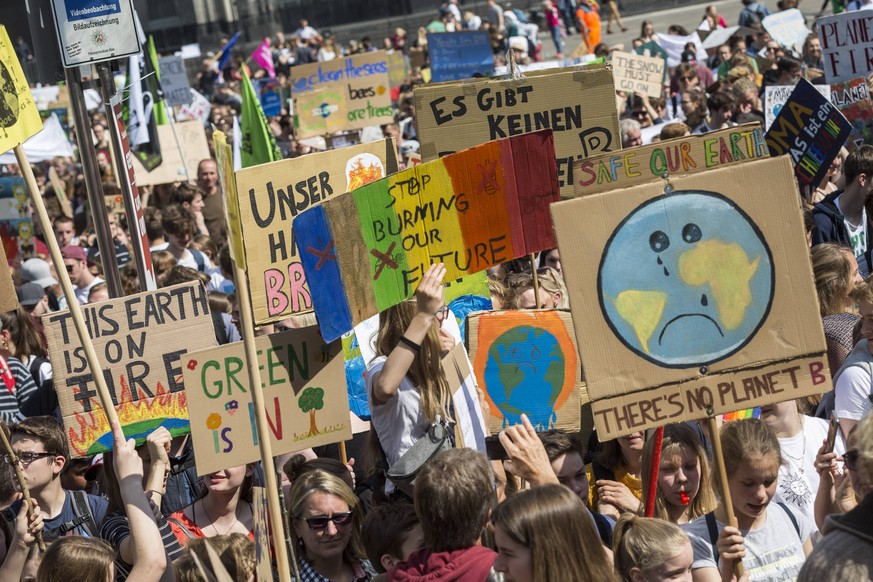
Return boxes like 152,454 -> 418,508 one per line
764,79 -> 852,190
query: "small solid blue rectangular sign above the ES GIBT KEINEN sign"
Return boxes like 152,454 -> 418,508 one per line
427,30 -> 494,83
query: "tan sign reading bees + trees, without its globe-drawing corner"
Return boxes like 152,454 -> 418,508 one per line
291,51 -> 394,129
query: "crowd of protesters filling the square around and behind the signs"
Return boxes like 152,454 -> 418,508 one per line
0,0 -> 873,582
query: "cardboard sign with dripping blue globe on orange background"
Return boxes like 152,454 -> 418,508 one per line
467,310 -> 582,432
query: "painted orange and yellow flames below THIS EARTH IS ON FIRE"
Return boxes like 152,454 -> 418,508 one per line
64,376 -> 189,457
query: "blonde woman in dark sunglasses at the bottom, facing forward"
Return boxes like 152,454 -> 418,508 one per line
288,470 -> 376,582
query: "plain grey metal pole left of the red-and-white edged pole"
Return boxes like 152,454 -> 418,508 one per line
65,65 -> 124,300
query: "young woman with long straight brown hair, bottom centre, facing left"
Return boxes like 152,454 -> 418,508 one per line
491,484 -> 616,582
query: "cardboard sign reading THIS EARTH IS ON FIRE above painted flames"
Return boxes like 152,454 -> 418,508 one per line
42,282 -> 216,457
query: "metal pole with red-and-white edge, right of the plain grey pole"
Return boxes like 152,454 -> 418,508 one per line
97,63 -> 158,291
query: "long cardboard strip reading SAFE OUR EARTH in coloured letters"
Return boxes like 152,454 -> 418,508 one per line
573,123 -> 769,197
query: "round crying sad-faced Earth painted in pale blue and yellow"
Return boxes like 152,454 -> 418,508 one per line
597,190 -> 775,368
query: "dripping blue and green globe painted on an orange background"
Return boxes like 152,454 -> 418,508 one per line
485,325 -> 566,430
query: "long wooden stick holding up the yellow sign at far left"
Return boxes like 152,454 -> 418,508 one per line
15,145 -> 121,434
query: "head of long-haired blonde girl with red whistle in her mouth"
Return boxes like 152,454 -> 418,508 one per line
642,423 -> 716,524
